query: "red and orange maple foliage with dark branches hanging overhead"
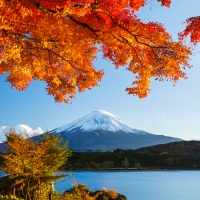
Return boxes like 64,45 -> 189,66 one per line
0,0 -> 191,102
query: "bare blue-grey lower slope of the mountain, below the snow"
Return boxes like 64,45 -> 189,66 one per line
60,130 -> 181,151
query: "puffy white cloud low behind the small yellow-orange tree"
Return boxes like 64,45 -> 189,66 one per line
0,124 -> 43,143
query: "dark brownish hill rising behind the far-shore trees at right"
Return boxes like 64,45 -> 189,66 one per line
135,141 -> 200,156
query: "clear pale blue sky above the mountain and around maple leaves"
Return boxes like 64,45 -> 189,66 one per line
0,0 -> 200,139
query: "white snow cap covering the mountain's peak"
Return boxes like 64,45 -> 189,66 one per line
52,110 -> 144,133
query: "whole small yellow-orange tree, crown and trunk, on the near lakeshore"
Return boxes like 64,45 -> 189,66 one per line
1,130 -> 71,200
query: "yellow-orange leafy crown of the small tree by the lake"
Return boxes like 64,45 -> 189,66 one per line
1,130 -> 72,179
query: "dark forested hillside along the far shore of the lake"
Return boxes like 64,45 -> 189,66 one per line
63,141 -> 200,170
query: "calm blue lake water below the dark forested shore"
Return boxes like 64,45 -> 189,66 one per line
55,170 -> 200,200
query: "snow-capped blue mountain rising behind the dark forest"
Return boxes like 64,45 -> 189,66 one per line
51,110 -> 182,151
